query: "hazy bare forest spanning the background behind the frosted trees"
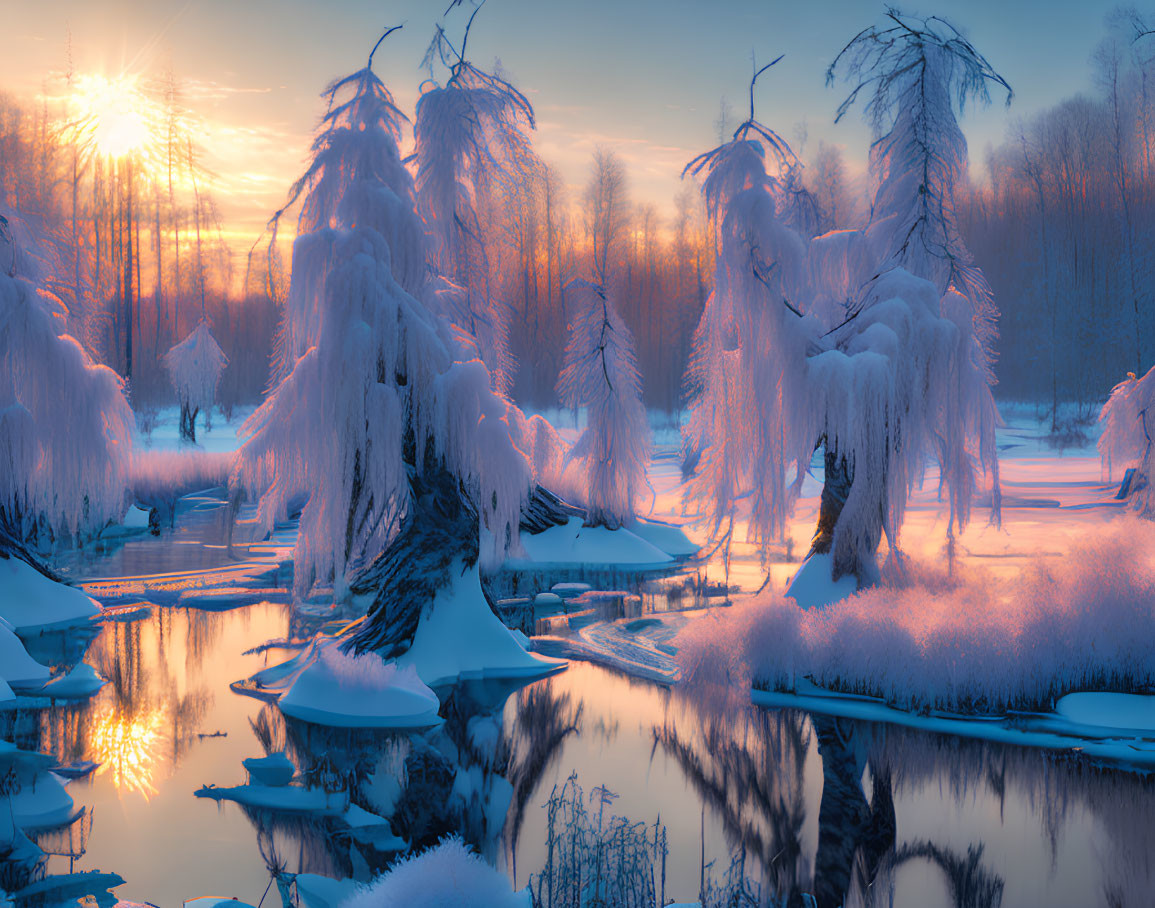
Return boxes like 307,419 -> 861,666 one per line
0,13 -> 1155,417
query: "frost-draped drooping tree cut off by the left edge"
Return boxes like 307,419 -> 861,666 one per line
0,203 -> 133,553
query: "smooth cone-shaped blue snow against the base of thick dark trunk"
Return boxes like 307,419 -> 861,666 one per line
396,560 -> 565,687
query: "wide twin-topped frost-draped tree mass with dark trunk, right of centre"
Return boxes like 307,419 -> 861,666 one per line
687,22 -> 997,586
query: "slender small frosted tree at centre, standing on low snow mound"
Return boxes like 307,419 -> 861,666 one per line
558,281 -> 650,529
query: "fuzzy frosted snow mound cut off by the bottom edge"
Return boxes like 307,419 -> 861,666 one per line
342,838 -> 532,908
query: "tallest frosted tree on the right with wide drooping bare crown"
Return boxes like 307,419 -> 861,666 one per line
827,8 -> 1013,571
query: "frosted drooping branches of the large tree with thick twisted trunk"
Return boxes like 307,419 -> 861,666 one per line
234,42 -> 531,608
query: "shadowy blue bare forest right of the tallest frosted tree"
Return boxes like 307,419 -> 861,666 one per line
960,12 -> 1155,418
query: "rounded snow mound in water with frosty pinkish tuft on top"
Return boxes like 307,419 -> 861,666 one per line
278,640 -> 440,728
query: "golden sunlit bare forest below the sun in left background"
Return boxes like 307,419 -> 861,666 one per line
0,75 -> 277,409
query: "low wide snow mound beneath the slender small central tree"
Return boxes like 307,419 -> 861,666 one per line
506,518 -> 673,571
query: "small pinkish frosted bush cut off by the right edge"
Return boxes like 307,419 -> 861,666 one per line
1098,369 -> 1155,508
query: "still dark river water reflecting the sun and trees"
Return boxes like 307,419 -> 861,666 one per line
9,487 -> 1155,908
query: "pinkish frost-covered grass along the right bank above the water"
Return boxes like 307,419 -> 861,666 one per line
677,519 -> 1155,714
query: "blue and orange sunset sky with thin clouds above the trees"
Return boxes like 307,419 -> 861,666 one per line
0,0 -> 1136,238
